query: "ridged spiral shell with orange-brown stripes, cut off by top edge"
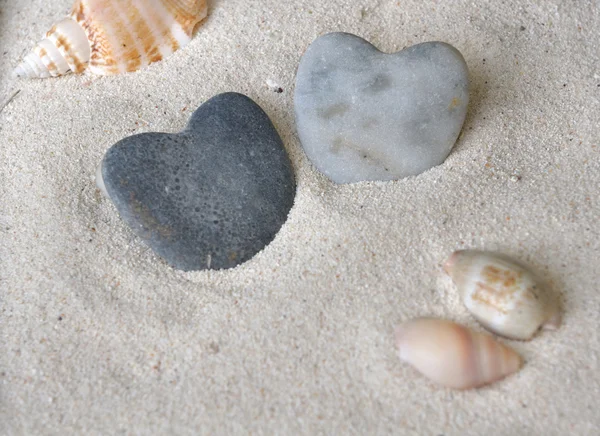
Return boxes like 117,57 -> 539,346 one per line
14,0 -> 208,78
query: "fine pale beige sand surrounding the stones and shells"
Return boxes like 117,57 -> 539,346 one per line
0,0 -> 600,435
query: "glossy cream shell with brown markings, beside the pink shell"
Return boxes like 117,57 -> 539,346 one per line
444,250 -> 560,340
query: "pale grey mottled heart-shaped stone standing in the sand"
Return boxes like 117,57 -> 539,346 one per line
294,33 -> 469,183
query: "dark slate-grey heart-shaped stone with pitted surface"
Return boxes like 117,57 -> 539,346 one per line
98,93 -> 295,271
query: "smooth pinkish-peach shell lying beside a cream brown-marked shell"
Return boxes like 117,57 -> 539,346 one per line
396,318 -> 522,389
